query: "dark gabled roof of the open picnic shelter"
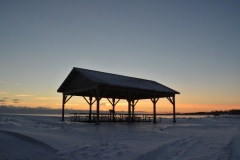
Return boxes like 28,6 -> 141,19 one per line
57,67 -> 180,98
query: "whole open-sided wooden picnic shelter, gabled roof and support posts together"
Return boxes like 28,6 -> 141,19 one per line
57,67 -> 180,124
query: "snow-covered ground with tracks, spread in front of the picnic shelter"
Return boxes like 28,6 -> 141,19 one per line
0,115 -> 240,160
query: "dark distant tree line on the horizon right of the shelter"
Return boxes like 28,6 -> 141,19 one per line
181,109 -> 240,116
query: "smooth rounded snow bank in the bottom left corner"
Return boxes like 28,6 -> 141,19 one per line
0,130 -> 56,160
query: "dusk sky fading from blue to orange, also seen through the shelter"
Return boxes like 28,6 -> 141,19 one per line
0,0 -> 240,112
